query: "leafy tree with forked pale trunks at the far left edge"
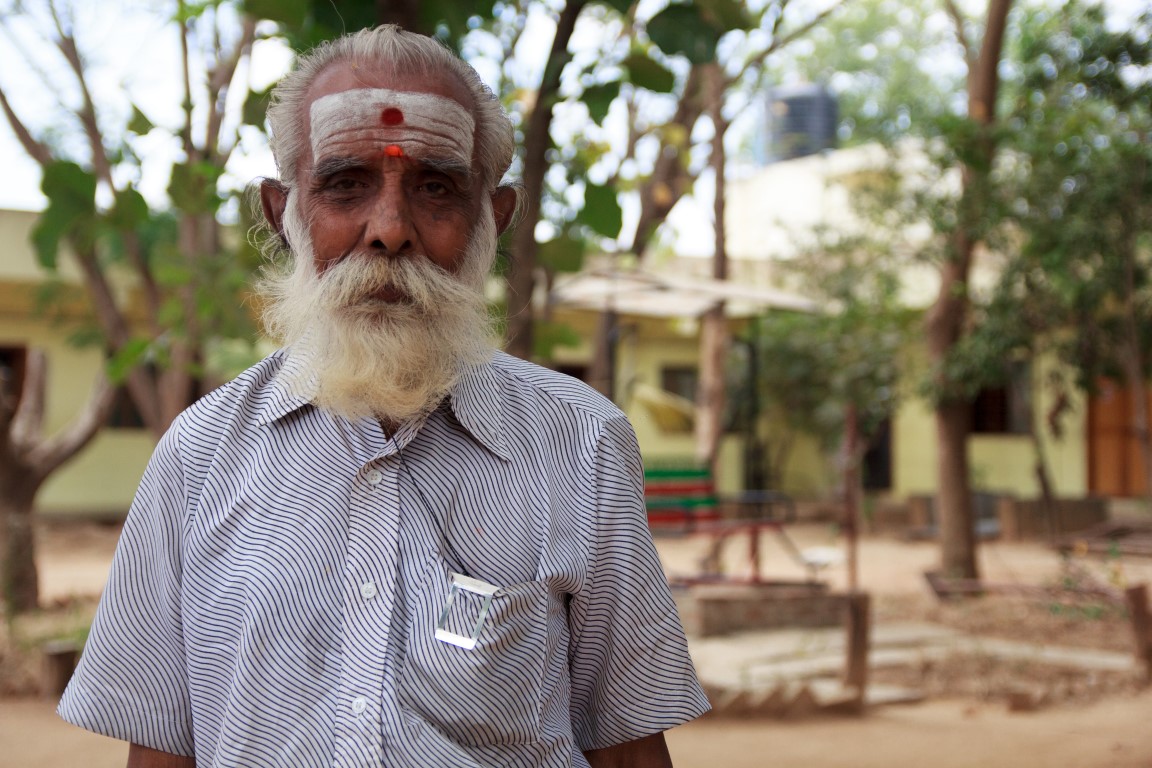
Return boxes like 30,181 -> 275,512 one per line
0,0 -> 267,610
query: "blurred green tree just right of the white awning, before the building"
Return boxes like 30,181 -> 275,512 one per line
746,208 -> 917,487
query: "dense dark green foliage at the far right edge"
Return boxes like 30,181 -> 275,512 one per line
975,2 -> 1152,499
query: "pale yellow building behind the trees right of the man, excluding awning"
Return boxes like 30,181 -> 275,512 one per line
554,146 -> 1105,513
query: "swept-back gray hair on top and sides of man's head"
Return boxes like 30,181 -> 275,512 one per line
268,24 -> 515,191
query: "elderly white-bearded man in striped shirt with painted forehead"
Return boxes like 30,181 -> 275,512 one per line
60,26 -> 707,768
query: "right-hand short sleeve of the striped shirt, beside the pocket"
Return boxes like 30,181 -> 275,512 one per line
569,417 -> 708,750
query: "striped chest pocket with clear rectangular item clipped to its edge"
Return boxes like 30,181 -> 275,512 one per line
400,560 -> 548,746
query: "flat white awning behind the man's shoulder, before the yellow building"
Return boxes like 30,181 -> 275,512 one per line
548,269 -> 819,318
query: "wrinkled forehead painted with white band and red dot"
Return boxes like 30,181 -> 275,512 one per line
310,88 -> 476,168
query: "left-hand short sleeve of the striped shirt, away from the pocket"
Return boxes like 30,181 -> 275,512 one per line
58,420 -> 192,755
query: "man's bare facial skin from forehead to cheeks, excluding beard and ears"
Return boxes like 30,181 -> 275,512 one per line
293,62 -> 491,287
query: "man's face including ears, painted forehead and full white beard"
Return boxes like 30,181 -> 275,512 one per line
257,58 -> 516,425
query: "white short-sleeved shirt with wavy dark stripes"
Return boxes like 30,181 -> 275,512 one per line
59,352 -> 708,768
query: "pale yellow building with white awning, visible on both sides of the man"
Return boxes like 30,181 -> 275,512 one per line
0,138 -> 1144,514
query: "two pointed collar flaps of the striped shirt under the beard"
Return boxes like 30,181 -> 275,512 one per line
258,349 -> 511,462
